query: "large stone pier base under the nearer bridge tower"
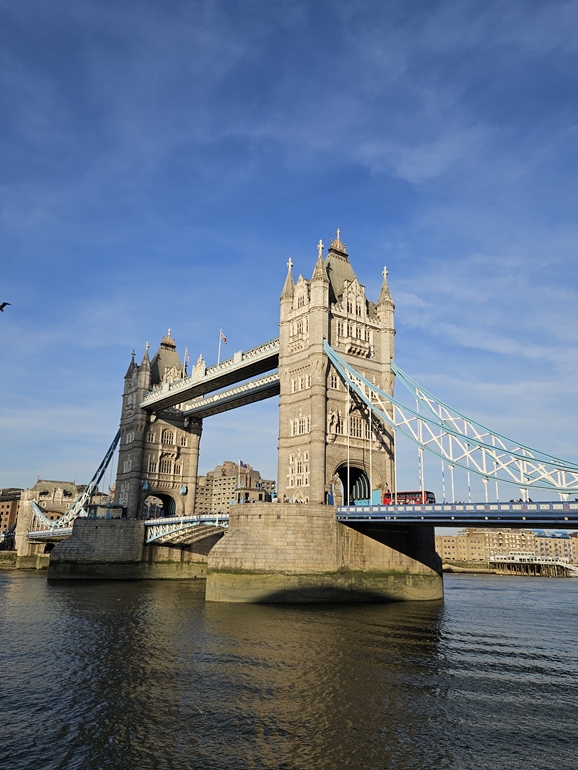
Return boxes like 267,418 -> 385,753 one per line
206,503 -> 443,603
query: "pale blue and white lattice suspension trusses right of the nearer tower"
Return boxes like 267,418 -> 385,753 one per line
325,343 -> 578,497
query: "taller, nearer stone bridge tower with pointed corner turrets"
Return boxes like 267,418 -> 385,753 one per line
278,230 -> 395,504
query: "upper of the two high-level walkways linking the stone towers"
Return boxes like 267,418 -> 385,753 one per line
140,338 -> 279,414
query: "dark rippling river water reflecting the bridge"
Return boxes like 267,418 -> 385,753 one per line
0,572 -> 578,770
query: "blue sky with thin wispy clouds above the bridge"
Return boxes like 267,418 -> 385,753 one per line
0,0 -> 578,504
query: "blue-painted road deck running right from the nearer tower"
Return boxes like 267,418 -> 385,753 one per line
337,501 -> 578,529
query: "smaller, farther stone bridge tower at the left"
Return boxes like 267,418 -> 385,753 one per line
115,329 -> 202,519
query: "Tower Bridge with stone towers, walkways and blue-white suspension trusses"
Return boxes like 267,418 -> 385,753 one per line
19,231 -> 578,601
